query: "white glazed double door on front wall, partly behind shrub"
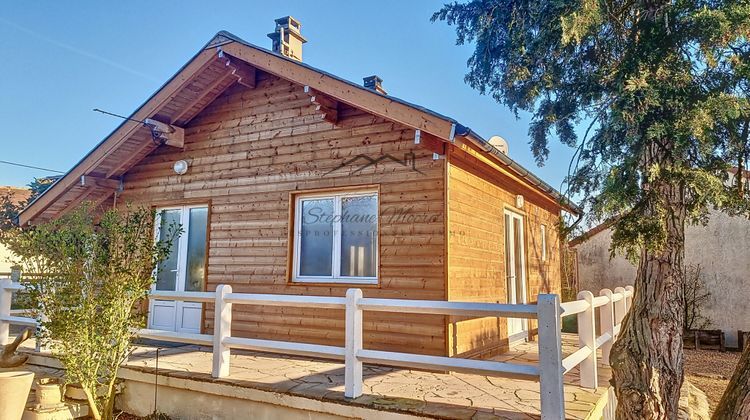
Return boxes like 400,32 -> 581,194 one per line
149,206 -> 208,333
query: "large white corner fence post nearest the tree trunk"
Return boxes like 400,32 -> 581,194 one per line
537,294 -> 565,420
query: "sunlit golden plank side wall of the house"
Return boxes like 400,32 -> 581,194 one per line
447,147 -> 560,357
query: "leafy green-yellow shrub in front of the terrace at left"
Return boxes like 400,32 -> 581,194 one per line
4,204 -> 180,420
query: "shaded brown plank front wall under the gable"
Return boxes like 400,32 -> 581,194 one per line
120,73 -> 447,354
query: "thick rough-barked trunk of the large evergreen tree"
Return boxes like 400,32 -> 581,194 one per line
610,158 -> 687,420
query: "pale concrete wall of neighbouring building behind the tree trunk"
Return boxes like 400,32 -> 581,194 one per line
575,212 -> 750,347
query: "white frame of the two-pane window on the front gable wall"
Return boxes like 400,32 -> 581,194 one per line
292,189 -> 380,284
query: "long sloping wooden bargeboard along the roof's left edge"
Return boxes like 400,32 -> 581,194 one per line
18,49 -> 217,226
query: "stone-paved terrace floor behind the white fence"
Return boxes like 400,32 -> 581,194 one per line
20,335 -> 610,419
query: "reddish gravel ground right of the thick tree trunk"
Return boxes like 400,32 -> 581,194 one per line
685,349 -> 742,414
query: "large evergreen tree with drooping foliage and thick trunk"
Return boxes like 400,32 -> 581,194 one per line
433,0 -> 750,419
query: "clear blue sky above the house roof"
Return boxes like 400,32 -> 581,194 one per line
0,0 -> 572,188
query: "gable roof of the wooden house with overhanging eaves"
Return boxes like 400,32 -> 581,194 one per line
18,31 -> 580,226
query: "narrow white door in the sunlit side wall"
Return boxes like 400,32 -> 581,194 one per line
505,210 -> 528,343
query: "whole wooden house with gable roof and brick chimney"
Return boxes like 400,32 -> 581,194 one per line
20,17 -> 579,356
